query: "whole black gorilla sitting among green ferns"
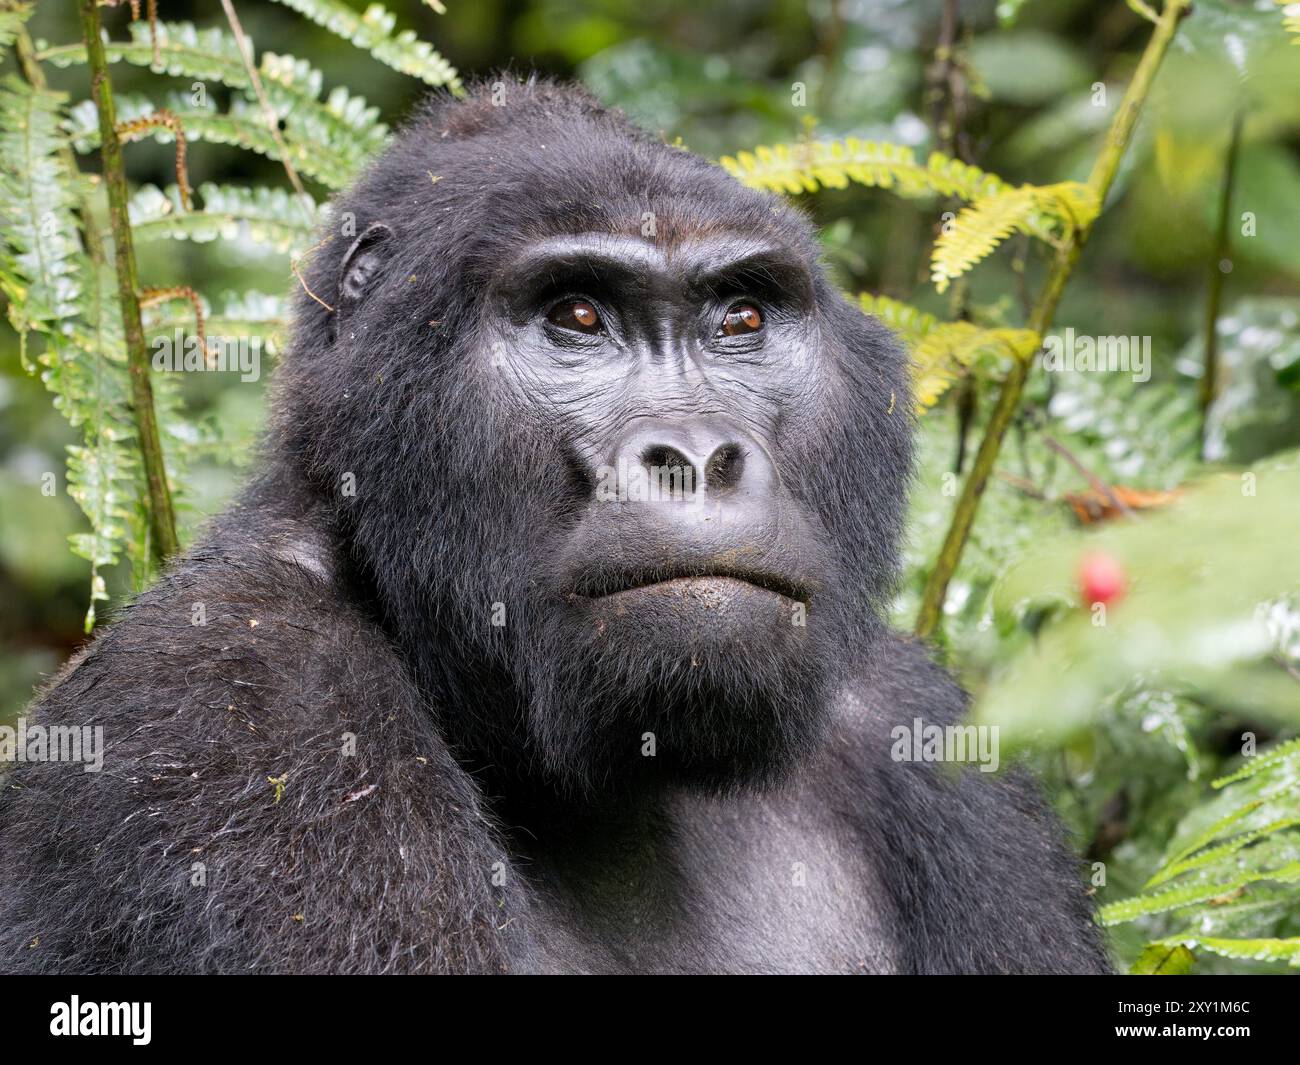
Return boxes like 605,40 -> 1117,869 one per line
0,79 -> 1109,974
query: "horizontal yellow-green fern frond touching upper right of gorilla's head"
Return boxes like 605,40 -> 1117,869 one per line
720,137 -> 1008,200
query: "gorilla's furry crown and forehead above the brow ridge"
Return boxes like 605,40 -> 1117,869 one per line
384,98 -> 818,261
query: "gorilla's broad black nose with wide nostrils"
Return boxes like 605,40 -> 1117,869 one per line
597,419 -> 776,502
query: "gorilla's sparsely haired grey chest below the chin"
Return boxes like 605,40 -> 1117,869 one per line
501,795 -> 897,973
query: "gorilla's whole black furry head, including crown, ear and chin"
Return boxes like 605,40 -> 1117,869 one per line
277,83 -> 911,791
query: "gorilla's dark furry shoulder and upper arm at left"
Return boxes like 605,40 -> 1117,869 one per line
0,523 -> 512,973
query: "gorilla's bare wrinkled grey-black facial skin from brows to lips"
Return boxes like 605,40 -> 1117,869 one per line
490,234 -> 827,616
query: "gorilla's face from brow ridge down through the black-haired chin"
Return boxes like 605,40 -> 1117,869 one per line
488,233 -> 839,780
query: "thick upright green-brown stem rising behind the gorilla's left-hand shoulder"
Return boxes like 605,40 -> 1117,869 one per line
81,0 -> 179,562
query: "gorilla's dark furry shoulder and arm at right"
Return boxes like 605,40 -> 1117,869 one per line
809,636 -> 1112,973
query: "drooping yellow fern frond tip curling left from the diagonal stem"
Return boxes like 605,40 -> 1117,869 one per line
931,182 -> 1100,291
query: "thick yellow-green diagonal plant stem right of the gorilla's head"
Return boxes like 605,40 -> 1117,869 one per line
915,0 -> 1191,636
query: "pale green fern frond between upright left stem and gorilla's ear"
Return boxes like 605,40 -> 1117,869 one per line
130,182 -> 317,252
